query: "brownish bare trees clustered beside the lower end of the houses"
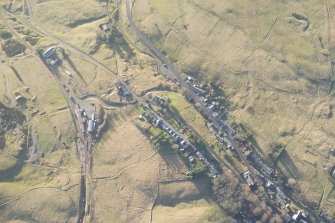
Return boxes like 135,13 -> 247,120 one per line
212,171 -> 283,223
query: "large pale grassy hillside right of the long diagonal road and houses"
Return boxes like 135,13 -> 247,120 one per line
132,0 -> 335,216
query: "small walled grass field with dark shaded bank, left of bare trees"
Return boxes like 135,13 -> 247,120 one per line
152,179 -> 224,223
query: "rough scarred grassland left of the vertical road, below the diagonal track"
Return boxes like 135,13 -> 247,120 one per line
0,12 -> 80,222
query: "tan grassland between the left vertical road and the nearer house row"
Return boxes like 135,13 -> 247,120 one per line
91,108 -> 224,222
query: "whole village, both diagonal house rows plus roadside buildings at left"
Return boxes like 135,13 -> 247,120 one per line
42,41 -> 320,223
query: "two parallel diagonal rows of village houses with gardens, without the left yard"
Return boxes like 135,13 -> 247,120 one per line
134,72 -> 316,223
